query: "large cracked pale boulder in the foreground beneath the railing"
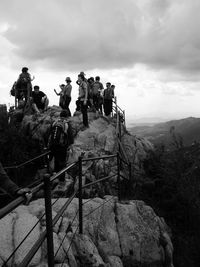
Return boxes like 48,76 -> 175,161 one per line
0,196 -> 173,267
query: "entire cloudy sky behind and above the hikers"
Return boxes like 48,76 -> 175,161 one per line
0,0 -> 200,125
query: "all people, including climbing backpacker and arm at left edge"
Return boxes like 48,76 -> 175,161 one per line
0,67 -> 115,207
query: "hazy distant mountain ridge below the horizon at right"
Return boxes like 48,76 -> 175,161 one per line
128,117 -> 200,146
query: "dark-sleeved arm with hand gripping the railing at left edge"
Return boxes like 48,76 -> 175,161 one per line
0,162 -> 32,204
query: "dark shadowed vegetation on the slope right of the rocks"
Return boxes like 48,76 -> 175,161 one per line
134,143 -> 200,267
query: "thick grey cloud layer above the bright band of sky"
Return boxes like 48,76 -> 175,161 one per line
0,0 -> 200,72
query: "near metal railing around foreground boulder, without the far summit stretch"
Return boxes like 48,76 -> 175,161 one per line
0,154 -> 131,267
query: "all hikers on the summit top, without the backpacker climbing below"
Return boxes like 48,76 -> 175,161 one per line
13,67 -> 115,127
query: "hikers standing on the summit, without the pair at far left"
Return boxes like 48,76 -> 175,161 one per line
54,71 -> 115,127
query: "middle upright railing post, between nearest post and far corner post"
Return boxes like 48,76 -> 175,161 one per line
78,156 -> 83,234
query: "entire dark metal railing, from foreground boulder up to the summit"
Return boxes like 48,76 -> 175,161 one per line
0,96 -> 132,267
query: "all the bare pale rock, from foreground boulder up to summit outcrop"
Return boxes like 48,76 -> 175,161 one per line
0,106 -> 173,267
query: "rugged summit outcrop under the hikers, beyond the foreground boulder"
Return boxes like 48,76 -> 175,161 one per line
19,106 -> 153,197
